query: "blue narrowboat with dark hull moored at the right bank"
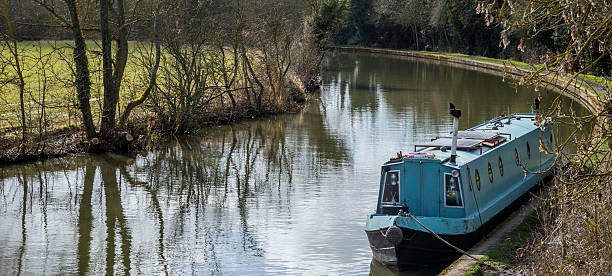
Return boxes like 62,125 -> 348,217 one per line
366,103 -> 556,270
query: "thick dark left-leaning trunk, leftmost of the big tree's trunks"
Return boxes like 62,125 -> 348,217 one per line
64,0 -> 96,139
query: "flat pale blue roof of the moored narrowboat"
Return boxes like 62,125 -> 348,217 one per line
406,114 -> 538,166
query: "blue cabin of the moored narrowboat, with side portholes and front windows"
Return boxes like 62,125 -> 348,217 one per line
376,114 -> 555,234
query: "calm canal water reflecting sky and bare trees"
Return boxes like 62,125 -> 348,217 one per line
0,54 -> 581,275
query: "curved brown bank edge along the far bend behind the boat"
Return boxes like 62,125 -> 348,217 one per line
330,46 -> 608,114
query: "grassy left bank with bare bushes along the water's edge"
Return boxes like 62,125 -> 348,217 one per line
0,38 -> 322,165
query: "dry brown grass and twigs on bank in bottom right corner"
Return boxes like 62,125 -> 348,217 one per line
516,172 -> 612,275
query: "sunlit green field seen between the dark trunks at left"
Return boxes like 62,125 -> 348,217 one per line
0,41 -> 155,128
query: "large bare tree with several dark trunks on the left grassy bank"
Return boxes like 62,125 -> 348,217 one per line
35,0 -> 160,142
